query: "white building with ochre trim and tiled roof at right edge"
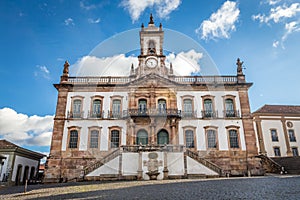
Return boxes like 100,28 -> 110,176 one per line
253,105 -> 300,157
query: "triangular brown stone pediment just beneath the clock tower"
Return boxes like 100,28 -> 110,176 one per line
129,73 -> 178,87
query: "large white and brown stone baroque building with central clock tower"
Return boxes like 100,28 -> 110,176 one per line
45,16 -> 263,182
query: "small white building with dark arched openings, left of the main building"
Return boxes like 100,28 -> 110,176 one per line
0,140 -> 45,185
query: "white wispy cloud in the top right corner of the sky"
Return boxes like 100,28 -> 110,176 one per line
252,3 -> 300,23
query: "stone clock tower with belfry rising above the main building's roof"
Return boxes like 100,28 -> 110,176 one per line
136,14 -> 169,78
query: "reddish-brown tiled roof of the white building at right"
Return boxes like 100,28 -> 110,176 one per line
254,105 -> 300,114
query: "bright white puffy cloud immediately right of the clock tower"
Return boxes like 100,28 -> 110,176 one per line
166,49 -> 203,76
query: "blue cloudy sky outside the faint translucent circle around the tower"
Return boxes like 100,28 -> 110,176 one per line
0,0 -> 300,152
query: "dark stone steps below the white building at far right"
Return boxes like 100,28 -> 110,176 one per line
272,156 -> 300,174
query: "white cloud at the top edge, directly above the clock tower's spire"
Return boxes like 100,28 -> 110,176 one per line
121,0 -> 181,22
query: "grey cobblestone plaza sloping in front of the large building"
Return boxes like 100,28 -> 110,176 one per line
0,175 -> 300,199
